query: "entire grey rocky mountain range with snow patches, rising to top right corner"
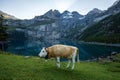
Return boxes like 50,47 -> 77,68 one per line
3,0 -> 120,38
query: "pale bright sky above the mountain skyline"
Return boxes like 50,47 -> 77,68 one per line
0,0 -> 116,19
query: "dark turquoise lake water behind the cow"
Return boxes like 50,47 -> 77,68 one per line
7,39 -> 120,60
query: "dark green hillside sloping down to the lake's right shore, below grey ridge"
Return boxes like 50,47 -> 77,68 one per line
77,13 -> 120,43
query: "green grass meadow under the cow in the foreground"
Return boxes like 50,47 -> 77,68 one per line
0,52 -> 120,80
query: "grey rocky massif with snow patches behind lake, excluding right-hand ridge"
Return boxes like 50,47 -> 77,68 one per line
9,10 -> 83,39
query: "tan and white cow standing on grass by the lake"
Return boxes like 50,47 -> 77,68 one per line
38,44 -> 79,70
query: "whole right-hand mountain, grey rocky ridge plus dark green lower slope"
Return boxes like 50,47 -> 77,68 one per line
76,0 -> 120,43
